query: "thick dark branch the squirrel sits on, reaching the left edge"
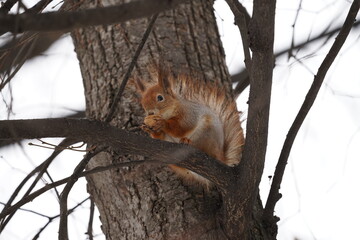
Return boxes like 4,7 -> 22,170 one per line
0,119 -> 234,187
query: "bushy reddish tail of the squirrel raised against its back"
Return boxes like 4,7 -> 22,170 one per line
150,70 -> 244,165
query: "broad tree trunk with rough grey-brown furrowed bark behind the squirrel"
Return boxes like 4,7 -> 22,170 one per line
72,0 -> 266,240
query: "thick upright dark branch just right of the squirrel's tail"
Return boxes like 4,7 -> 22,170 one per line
239,0 -> 275,203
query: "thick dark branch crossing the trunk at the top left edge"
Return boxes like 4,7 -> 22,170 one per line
0,0 -> 187,33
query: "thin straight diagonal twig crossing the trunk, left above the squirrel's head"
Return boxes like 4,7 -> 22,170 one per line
105,14 -> 159,122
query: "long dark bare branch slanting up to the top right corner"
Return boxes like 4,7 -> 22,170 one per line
263,0 -> 360,231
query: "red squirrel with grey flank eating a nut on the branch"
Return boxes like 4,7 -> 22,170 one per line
134,67 -> 244,185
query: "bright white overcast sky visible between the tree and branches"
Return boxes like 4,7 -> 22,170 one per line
0,0 -> 360,240
